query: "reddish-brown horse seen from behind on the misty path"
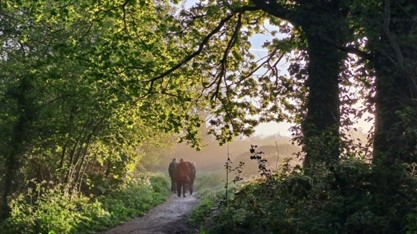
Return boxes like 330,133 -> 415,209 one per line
175,159 -> 196,197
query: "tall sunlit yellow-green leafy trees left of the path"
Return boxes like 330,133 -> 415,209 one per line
0,1 -> 205,217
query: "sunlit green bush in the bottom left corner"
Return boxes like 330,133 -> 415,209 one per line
3,181 -> 109,233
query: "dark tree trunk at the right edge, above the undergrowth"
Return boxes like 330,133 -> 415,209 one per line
370,0 -> 417,167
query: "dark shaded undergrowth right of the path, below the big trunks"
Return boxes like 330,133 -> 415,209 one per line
189,145 -> 417,234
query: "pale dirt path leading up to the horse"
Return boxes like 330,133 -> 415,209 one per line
100,194 -> 197,234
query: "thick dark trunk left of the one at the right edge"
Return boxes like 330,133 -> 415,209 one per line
297,2 -> 347,174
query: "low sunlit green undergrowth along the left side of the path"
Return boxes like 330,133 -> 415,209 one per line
0,172 -> 170,234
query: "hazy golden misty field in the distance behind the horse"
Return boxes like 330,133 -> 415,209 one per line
156,132 -> 366,192
